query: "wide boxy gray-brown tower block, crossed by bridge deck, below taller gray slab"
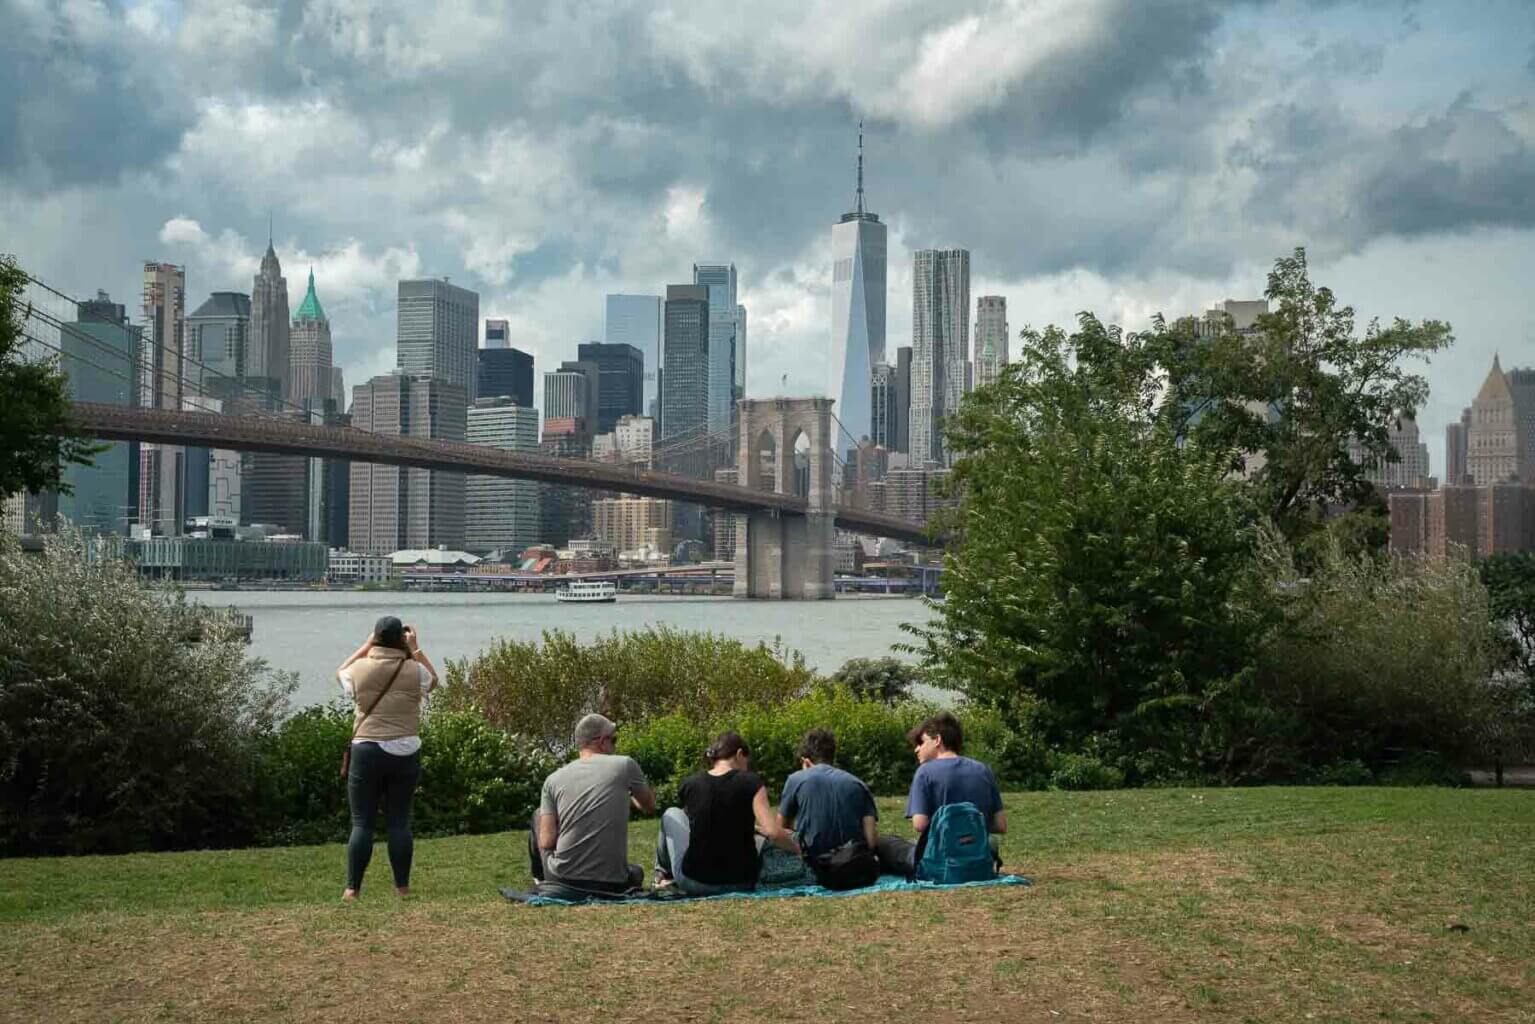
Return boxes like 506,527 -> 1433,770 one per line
348,374 -> 473,554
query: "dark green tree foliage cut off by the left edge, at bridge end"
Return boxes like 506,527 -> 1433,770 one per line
0,255 -> 98,499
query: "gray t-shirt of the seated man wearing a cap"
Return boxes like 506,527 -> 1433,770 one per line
539,754 -> 648,883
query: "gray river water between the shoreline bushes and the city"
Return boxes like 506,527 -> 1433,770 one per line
189,591 -> 929,706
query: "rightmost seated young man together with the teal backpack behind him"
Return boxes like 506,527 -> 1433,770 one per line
876,711 -> 1007,883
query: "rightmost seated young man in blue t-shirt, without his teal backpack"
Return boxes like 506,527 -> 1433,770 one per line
876,711 -> 1007,878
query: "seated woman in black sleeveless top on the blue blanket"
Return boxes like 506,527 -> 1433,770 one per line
655,732 -> 800,897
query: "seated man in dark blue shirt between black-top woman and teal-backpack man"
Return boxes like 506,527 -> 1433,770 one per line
778,729 -> 880,889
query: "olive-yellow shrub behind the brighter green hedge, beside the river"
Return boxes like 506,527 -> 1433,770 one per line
444,626 -> 815,751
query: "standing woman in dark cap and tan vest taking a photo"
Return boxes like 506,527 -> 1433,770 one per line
336,616 -> 437,900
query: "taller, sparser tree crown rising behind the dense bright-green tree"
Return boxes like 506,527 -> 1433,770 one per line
1147,249 -> 1452,537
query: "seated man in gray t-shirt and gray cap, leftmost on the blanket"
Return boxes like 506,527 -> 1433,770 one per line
528,714 -> 655,894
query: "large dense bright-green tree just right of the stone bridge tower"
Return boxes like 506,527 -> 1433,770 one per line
913,315 -> 1259,778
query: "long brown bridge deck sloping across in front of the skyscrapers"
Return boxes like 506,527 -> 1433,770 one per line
72,402 -> 932,543
